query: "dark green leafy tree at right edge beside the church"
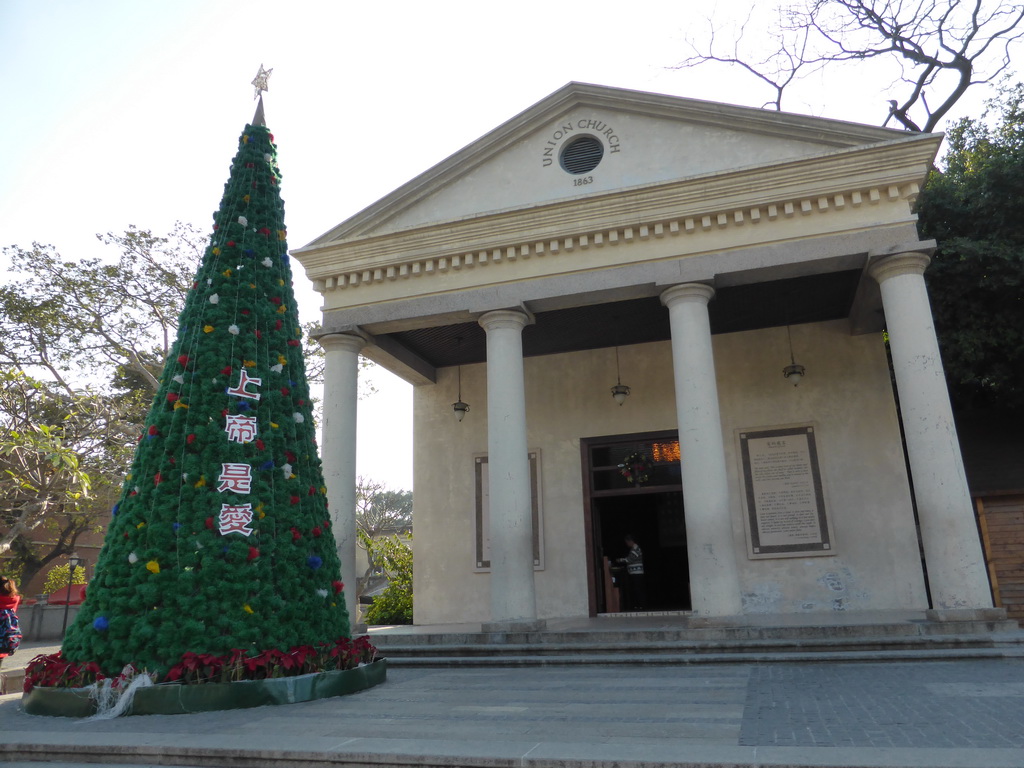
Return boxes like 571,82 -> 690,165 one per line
918,85 -> 1024,413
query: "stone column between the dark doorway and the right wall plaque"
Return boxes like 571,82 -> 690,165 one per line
662,283 -> 742,616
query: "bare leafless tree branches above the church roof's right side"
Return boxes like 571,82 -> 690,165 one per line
673,0 -> 1024,131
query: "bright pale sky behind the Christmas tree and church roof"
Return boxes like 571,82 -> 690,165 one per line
0,0 -> 1007,489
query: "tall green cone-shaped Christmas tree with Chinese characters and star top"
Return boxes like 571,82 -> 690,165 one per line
62,82 -> 349,675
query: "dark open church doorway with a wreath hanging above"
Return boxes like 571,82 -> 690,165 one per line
581,431 -> 691,615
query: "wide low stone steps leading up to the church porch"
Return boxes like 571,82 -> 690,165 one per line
371,611 -> 1024,667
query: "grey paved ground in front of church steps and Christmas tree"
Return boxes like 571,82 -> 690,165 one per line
0,659 -> 1024,768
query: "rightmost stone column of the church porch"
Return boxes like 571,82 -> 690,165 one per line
865,253 -> 992,611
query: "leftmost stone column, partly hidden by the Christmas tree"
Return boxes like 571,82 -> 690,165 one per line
319,334 -> 366,631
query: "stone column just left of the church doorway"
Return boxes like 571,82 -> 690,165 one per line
479,309 -> 539,631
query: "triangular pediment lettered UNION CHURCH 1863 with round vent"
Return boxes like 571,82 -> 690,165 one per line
303,83 -> 912,244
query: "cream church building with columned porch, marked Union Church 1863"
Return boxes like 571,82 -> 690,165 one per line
294,83 -> 992,627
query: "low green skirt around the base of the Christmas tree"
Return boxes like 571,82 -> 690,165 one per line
22,658 -> 387,718
